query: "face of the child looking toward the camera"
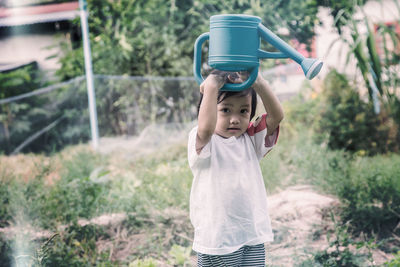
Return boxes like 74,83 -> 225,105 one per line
215,94 -> 251,138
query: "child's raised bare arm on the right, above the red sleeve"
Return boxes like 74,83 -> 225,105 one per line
253,72 -> 283,135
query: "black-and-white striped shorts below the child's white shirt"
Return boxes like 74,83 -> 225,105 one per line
197,244 -> 265,267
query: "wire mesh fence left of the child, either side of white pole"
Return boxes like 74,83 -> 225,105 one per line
0,75 -> 199,154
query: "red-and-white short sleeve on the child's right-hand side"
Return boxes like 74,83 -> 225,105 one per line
247,114 -> 279,160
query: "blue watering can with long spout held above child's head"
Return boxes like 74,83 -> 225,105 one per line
193,14 -> 323,91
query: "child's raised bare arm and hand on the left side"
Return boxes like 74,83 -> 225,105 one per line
196,74 -> 225,154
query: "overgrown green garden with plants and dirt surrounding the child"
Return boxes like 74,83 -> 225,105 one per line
0,0 -> 400,267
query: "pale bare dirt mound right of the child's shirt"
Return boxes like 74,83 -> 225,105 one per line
266,185 -> 392,267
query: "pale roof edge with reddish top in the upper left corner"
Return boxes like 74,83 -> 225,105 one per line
0,1 -> 79,27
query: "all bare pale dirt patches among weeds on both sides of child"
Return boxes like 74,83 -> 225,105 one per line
0,185 -> 392,267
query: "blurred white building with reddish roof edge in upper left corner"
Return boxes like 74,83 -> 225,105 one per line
0,0 -> 79,77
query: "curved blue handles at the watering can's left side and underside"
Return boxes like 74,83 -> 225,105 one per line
193,32 -> 258,91
